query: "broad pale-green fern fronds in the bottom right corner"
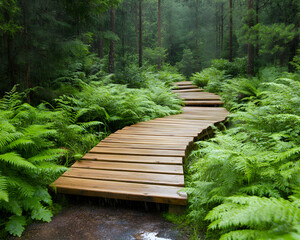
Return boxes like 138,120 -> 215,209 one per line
206,196 -> 300,240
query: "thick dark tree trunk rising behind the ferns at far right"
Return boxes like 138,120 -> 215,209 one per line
247,0 -> 255,76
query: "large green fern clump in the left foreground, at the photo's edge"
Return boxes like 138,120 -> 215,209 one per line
0,88 -> 66,236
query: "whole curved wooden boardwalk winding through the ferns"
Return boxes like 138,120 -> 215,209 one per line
54,81 -> 228,205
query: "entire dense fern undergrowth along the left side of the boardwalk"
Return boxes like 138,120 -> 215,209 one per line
0,62 -> 184,238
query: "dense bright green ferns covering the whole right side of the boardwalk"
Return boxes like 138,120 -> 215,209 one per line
185,59 -> 300,240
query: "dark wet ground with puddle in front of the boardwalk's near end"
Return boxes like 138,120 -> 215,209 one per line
12,199 -> 188,240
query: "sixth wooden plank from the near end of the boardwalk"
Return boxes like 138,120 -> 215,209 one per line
97,141 -> 186,150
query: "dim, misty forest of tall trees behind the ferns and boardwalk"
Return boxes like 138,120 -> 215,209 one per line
0,0 -> 299,100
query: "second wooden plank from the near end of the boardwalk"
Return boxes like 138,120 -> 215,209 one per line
63,168 -> 184,187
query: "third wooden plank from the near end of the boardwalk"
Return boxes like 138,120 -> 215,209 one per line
72,160 -> 183,175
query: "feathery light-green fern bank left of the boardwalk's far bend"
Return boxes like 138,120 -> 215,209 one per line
59,82 -> 181,132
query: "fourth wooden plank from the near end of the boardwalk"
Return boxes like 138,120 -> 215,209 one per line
82,153 -> 182,165
